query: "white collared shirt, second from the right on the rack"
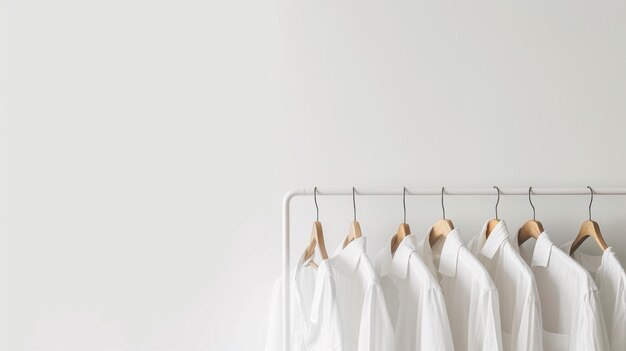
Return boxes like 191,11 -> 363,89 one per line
520,232 -> 609,351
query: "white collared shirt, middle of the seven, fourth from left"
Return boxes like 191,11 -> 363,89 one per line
416,229 -> 502,351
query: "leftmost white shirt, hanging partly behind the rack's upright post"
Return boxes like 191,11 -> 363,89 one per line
265,257 -> 347,351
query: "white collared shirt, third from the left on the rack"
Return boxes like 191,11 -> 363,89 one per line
374,235 -> 454,351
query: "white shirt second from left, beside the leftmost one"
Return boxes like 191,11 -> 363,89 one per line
330,237 -> 395,351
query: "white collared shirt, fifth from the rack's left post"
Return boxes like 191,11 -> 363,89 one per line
468,220 -> 543,351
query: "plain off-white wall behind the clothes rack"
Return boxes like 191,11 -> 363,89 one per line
0,0 -> 626,351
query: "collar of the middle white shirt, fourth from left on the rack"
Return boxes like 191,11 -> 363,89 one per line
418,228 -> 463,277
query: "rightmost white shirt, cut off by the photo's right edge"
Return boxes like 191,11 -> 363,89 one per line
561,241 -> 626,351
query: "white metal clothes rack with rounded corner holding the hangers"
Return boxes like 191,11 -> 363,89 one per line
282,187 -> 626,351
